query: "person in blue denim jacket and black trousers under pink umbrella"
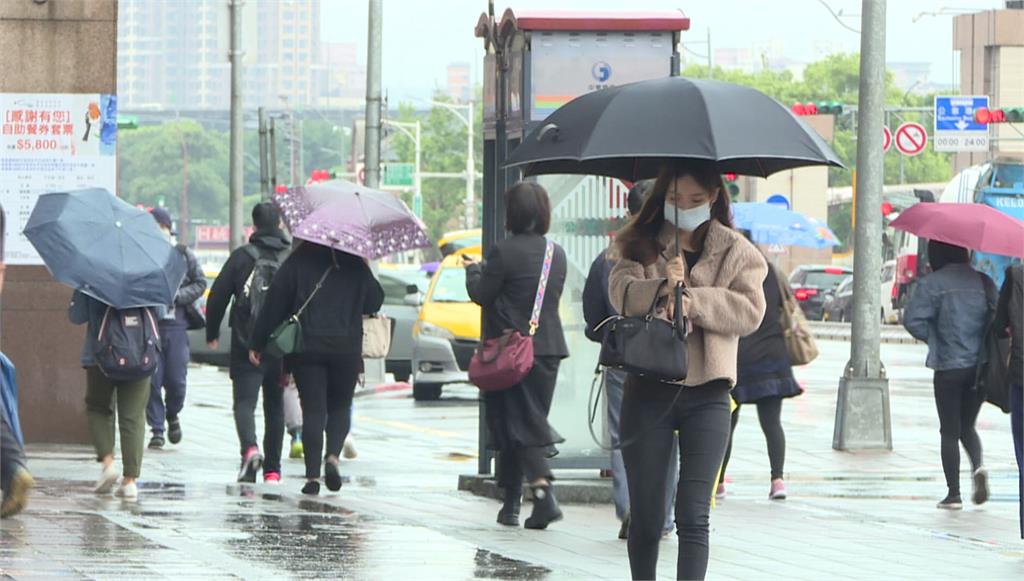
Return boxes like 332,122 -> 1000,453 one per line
903,240 -> 997,510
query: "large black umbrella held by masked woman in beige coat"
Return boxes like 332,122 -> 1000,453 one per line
507,77 -> 844,180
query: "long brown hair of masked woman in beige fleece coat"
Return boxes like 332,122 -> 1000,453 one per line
615,160 -> 732,264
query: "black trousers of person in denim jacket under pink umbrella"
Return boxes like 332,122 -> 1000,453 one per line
935,367 -> 982,496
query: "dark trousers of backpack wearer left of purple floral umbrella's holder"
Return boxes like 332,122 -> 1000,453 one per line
231,358 -> 285,473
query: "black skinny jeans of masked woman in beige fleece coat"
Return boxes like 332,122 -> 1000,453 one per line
621,376 -> 729,579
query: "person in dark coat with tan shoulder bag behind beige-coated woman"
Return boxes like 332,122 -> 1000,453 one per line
716,240 -> 804,500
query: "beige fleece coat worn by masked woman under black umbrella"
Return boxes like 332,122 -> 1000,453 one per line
608,220 -> 768,386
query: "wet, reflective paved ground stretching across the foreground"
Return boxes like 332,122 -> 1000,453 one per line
0,342 -> 1024,579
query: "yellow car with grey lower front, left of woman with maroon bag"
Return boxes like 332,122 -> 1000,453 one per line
413,247 -> 480,402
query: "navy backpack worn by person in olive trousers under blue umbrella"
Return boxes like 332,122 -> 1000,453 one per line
93,306 -> 160,382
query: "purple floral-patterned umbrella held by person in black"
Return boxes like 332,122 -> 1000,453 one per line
273,179 -> 430,259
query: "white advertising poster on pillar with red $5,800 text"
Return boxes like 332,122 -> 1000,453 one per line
0,93 -> 118,264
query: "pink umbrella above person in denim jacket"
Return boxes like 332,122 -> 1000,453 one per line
892,202 -> 1024,257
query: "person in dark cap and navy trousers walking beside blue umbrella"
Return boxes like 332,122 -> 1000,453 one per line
145,208 -> 206,450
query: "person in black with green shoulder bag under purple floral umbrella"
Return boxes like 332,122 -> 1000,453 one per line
249,242 -> 384,494
